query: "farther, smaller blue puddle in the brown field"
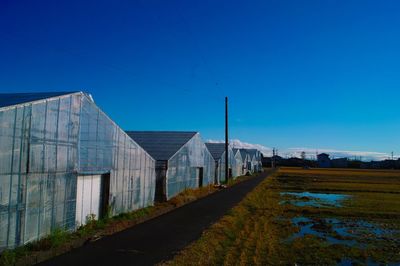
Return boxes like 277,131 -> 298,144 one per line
280,192 -> 351,207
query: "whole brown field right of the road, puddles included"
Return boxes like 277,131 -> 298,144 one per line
165,168 -> 400,265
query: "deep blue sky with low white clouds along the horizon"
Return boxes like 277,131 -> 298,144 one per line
0,0 -> 400,160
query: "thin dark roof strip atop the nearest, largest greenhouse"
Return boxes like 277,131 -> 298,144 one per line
0,92 -> 75,108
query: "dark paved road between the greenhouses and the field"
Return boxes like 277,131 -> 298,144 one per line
42,173 -> 267,265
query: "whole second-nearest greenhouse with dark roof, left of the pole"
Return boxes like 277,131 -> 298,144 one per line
127,131 -> 215,201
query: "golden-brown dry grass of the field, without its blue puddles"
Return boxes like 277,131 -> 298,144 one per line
164,168 -> 400,265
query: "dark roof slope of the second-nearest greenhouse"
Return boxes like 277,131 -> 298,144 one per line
126,131 -> 197,161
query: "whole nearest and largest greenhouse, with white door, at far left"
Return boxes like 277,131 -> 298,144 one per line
0,92 -> 155,250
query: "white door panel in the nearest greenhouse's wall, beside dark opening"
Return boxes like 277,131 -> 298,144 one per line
75,175 -> 101,227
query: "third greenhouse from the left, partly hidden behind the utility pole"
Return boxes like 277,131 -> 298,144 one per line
206,143 -> 240,184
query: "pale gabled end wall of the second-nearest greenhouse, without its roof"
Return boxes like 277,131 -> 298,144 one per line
166,133 -> 215,200
